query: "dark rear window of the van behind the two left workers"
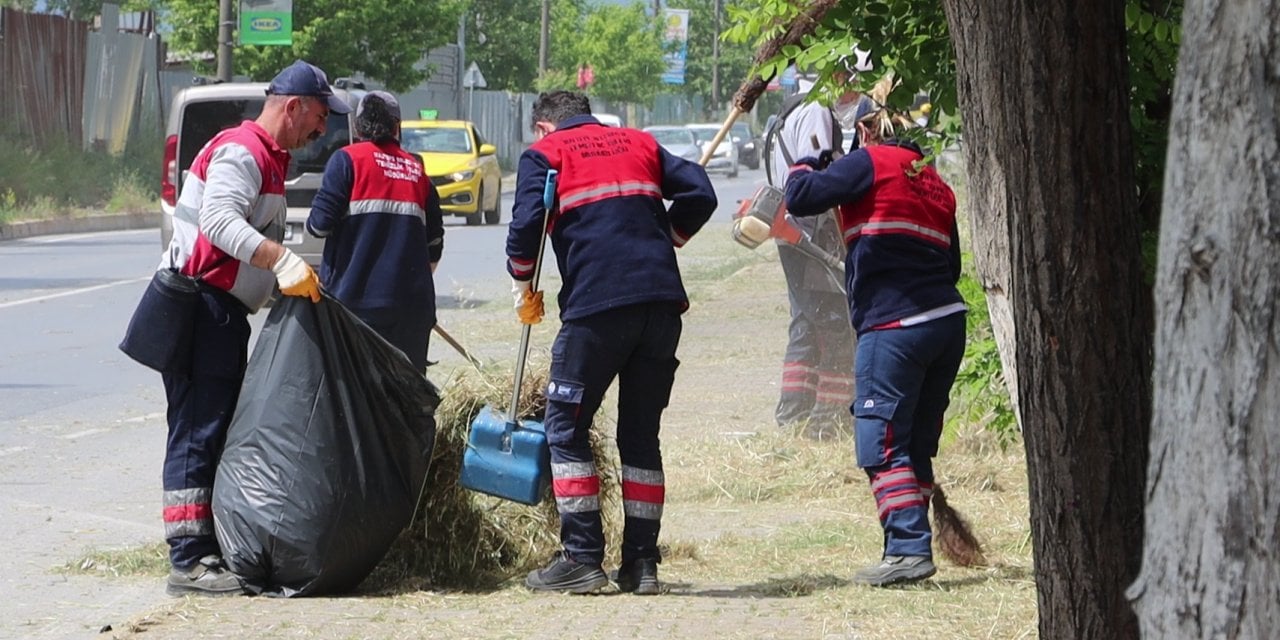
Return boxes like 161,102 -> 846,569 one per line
178,97 -> 351,185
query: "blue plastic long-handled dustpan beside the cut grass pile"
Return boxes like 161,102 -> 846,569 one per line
458,406 -> 552,504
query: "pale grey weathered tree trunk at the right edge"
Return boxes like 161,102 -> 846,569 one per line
1129,0 -> 1280,639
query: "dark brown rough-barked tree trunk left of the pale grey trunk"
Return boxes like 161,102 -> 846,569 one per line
945,0 -> 1151,640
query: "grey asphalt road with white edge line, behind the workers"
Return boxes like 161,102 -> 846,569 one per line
0,163 -> 763,639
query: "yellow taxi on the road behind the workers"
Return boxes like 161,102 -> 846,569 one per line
401,120 -> 502,224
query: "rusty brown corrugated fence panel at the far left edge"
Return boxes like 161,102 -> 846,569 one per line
0,9 -> 88,143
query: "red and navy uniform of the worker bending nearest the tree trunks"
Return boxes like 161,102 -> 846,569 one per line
786,141 -> 966,557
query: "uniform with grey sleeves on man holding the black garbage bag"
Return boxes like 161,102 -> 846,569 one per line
160,120 -> 289,568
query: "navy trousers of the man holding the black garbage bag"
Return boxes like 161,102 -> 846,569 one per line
163,292 -> 250,568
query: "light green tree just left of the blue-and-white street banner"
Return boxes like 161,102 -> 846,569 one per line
536,0 -> 666,102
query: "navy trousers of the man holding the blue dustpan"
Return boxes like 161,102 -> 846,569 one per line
545,303 -> 681,563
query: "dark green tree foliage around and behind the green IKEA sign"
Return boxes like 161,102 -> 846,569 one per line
163,0 -> 466,91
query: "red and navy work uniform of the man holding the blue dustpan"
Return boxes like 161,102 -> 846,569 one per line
507,115 -> 717,564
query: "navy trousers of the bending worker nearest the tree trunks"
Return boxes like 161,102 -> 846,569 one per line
852,314 -> 965,556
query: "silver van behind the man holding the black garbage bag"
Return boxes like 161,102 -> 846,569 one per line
160,82 -> 356,265
